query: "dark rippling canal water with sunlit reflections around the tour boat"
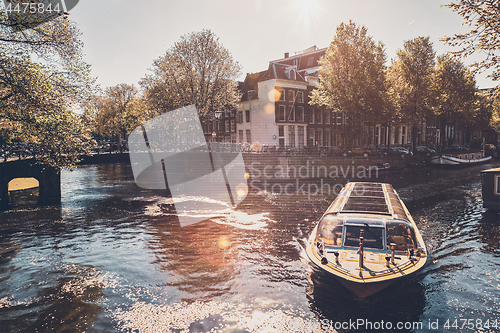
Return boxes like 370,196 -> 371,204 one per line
0,158 -> 500,332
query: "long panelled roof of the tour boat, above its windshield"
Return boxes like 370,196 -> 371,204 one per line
325,182 -> 410,221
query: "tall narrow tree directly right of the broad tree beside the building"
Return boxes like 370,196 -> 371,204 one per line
388,37 -> 435,150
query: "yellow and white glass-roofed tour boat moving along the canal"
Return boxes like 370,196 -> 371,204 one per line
306,182 -> 428,298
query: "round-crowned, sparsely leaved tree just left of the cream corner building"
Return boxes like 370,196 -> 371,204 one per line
141,30 -> 241,119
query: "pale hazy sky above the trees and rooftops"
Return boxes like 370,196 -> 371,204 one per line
70,0 -> 495,88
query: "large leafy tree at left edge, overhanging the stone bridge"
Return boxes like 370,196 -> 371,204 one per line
0,11 -> 93,167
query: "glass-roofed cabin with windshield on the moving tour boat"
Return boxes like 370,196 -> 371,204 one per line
316,183 -> 417,250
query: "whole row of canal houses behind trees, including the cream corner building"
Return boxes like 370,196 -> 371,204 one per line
204,46 -> 496,149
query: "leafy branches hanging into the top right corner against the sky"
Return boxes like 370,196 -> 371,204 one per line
441,0 -> 500,80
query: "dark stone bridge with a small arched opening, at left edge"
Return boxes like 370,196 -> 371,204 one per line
0,158 -> 61,210
